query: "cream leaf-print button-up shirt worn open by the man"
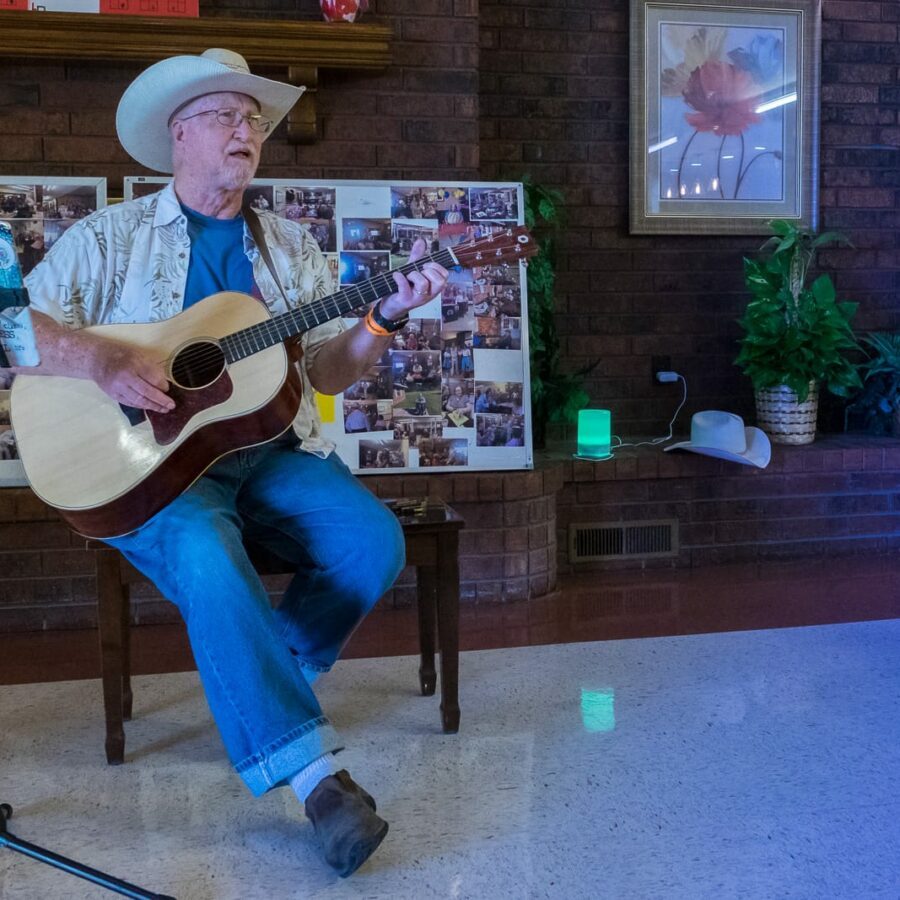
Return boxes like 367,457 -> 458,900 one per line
25,184 -> 344,456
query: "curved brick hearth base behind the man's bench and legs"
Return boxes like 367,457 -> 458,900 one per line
0,462 -> 563,634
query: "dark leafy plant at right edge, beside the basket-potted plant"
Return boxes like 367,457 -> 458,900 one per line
845,331 -> 900,437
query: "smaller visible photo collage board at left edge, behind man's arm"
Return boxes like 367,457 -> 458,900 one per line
0,175 -> 106,487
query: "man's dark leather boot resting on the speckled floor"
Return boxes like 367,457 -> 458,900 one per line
305,769 -> 388,878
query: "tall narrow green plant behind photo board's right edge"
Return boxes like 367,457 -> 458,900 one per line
522,176 -> 597,448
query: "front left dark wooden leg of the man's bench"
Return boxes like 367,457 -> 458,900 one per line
97,548 -> 127,765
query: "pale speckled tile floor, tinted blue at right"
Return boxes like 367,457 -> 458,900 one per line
0,624 -> 900,900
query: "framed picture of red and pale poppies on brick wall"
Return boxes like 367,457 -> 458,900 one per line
630,0 -> 822,234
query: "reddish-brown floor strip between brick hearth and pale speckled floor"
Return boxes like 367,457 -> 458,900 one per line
0,555 -> 900,684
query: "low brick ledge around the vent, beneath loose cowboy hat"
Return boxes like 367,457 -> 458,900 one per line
557,435 -> 900,574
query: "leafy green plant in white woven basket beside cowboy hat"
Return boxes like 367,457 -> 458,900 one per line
735,219 -> 861,444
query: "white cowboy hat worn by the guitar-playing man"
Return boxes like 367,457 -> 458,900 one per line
116,48 -> 306,173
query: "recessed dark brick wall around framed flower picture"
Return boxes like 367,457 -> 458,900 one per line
480,0 -> 900,435
